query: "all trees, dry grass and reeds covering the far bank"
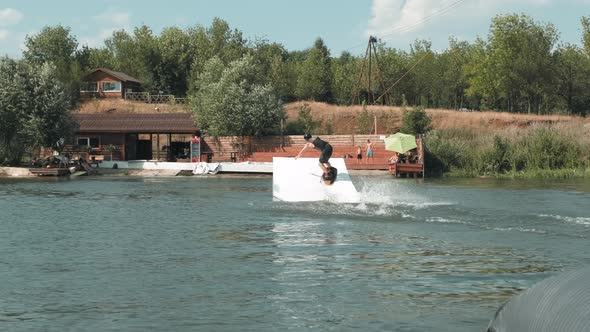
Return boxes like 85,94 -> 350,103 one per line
0,14 -> 590,176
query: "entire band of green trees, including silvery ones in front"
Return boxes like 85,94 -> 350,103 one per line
0,14 -> 590,160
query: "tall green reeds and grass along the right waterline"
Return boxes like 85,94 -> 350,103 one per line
425,122 -> 590,178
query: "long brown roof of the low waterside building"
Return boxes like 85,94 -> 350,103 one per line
73,113 -> 197,134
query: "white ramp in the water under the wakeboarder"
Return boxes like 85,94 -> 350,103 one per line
272,157 -> 361,203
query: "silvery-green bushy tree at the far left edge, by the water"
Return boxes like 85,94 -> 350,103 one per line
0,58 -> 74,164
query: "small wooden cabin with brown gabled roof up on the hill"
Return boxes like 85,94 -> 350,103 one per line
80,68 -> 141,98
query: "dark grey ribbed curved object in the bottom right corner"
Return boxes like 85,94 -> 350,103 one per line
487,267 -> 590,332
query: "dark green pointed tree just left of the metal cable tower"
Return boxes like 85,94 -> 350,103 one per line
296,38 -> 332,102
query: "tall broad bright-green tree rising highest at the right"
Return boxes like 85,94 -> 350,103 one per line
471,15 -> 557,113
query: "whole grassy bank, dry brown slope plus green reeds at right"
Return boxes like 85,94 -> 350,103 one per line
77,100 -> 590,178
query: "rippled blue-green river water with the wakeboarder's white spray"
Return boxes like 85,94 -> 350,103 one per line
0,175 -> 590,332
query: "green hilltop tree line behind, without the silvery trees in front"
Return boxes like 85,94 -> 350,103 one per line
13,14 -> 590,115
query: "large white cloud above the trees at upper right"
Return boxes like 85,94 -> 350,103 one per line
363,0 -> 590,51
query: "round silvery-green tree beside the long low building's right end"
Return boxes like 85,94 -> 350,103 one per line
189,56 -> 283,136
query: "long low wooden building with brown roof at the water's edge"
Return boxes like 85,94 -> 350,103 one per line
68,113 -> 197,161
